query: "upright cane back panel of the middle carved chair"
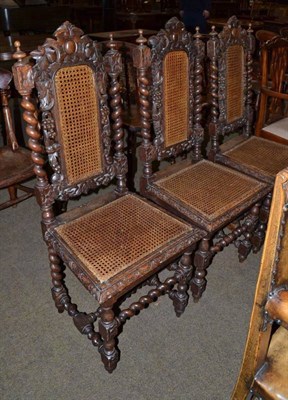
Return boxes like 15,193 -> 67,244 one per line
163,51 -> 189,147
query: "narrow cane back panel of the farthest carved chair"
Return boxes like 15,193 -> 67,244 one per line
226,45 -> 244,124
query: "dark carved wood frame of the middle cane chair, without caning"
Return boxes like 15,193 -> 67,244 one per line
134,17 -> 271,301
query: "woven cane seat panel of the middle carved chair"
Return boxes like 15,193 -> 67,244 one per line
156,161 -> 263,219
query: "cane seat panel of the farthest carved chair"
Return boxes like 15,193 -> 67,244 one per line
224,137 -> 288,176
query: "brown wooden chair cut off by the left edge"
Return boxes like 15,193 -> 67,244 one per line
0,68 -> 34,210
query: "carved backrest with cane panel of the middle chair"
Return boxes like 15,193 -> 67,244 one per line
134,17 -> 204,170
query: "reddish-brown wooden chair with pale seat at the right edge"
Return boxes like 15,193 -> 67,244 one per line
255,36 -> 288,144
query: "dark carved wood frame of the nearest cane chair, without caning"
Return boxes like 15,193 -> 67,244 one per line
13,21 -> 205,372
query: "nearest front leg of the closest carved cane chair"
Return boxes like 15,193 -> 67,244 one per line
99,305 -> 119,373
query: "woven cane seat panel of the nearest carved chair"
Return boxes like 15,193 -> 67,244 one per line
56,195 -> 192,282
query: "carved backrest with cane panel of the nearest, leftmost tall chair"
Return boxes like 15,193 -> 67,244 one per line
13,22 -> 126,212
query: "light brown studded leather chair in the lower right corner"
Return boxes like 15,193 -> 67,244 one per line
232,168 -> 288,400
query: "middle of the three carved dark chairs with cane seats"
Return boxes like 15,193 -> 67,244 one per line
134,17 -> 270,300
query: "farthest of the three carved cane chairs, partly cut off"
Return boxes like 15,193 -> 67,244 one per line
207,16 -> 288,188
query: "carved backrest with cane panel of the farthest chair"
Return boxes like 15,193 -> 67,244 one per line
207,16 -> 255,159
